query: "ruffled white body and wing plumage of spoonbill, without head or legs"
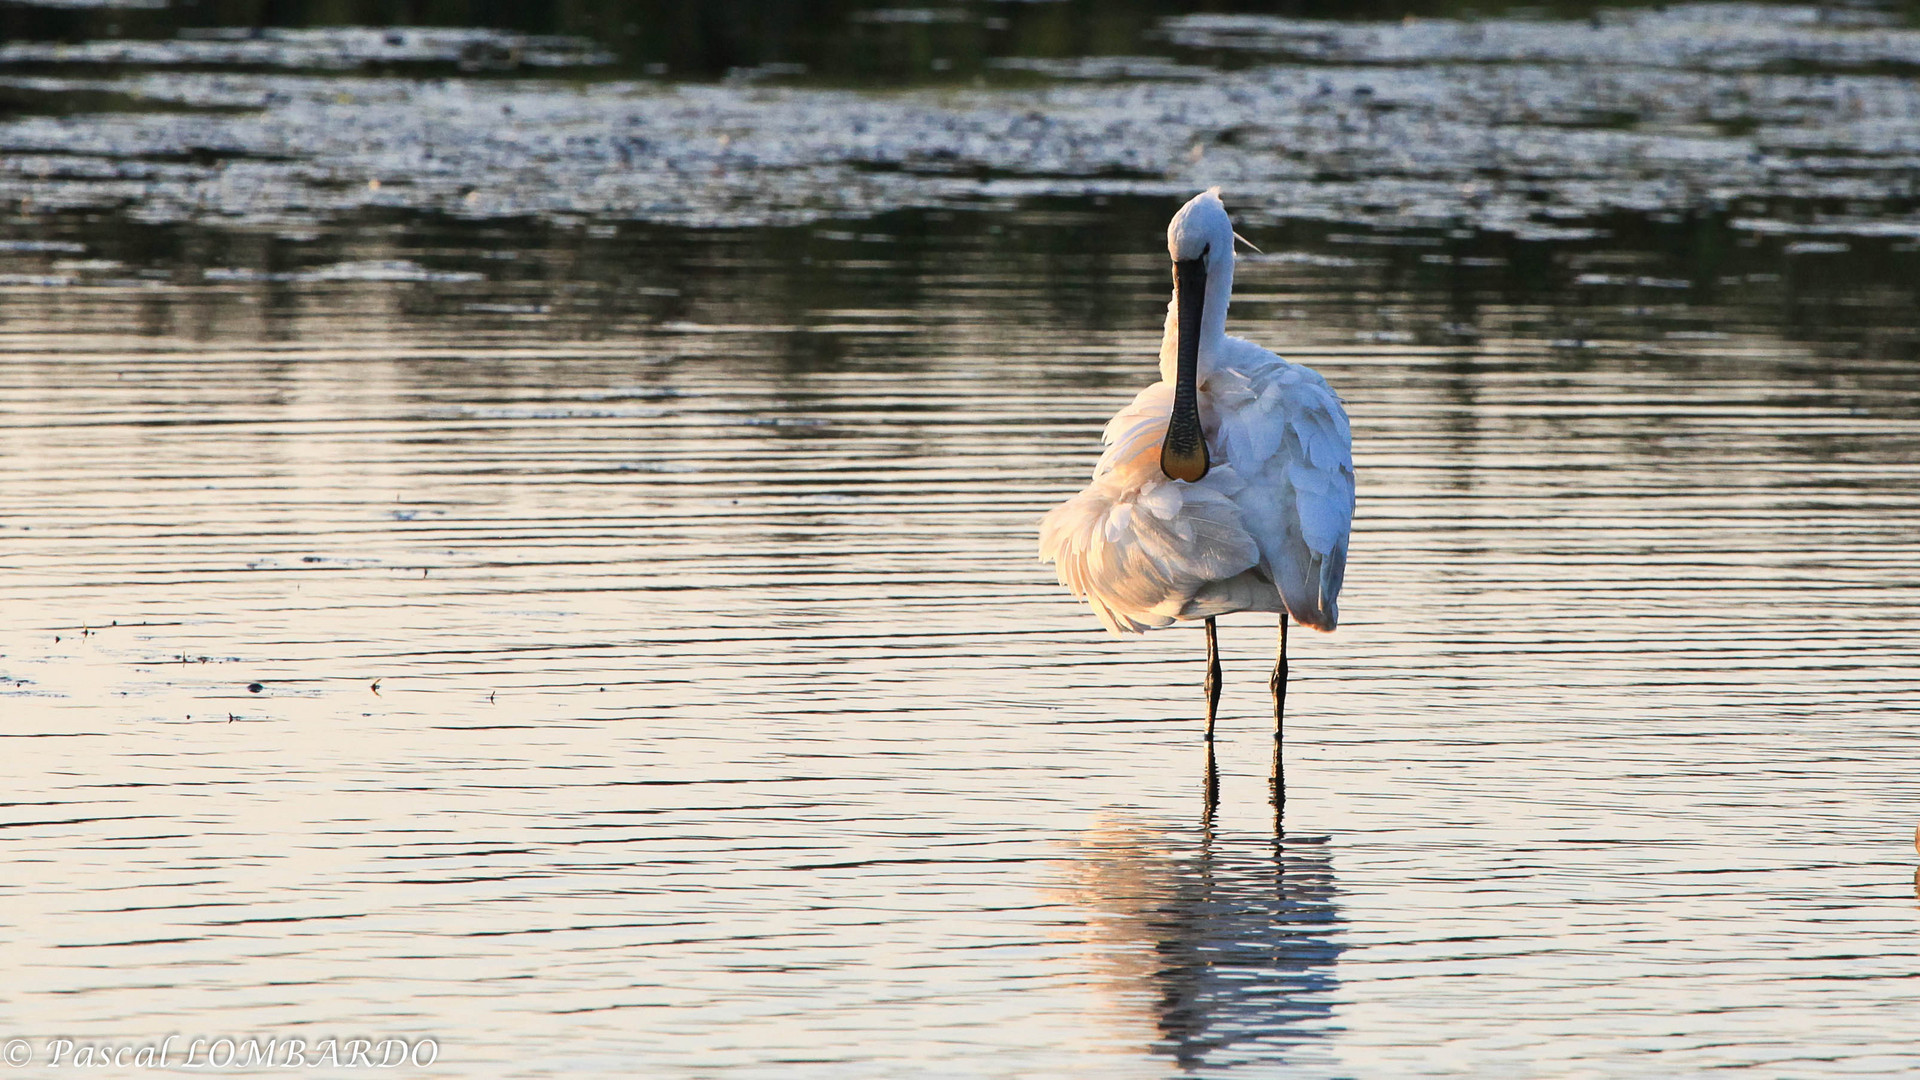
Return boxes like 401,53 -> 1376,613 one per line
1041,338 -> 1354,632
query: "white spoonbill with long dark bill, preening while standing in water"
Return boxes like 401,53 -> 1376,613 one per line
1041,188 -> 1354,782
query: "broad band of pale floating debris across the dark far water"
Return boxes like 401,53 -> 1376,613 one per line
0,6 -> 1920,242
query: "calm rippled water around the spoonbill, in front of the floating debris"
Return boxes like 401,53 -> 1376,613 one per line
0,4 -> 1920,1078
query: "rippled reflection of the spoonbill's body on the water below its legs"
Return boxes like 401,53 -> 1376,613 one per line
1066,828 -> 1344,1070
